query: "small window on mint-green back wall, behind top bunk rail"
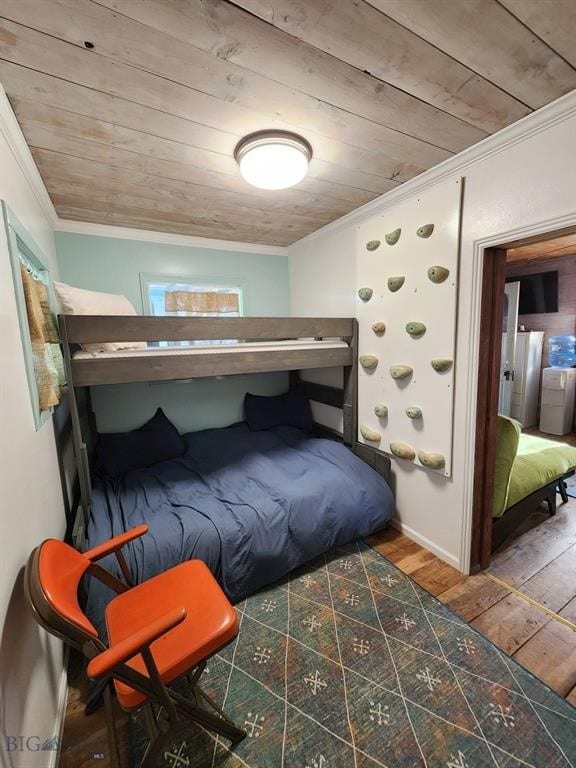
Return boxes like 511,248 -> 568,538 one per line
141,275 -> 244,347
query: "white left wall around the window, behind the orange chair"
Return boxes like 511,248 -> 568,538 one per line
0,88 -> 65,768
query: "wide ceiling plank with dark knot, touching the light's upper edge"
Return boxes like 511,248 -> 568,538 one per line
0,8 -> 452,168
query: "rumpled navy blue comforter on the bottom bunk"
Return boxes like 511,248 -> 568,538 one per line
87,423 -> 394,628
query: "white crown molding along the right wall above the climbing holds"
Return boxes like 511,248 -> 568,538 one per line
288,90 -> 576,253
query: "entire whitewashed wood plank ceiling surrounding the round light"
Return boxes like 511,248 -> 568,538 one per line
0,0 -> 576,245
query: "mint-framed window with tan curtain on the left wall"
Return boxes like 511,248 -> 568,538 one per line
1,201 -> 64,430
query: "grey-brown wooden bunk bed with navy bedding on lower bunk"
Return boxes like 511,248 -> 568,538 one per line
59,315 -> 394,613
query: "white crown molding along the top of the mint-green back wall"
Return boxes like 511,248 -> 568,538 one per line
54,218 -> 288,256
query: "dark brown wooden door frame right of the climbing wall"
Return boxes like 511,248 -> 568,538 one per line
471,227 -> 576,570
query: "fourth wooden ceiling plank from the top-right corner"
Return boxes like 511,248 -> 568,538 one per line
97,0 -> 487,152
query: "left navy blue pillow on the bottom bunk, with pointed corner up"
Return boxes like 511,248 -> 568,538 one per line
97,408 -> 186,477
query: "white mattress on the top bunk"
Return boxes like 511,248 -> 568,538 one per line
74,339 -> 348,360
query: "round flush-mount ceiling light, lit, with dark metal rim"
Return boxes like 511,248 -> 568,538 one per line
234,131 -> 312,189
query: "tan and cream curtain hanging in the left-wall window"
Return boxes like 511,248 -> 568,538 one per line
20,263 -> 65,411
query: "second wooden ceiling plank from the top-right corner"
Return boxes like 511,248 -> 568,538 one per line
366,0 -> 576,109
